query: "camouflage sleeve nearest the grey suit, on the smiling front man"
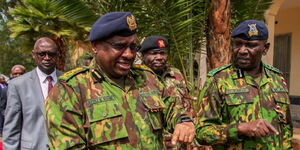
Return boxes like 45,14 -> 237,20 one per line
45,83 -> 86,149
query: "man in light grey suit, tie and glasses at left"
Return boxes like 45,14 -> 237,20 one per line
3,37 -> 62,150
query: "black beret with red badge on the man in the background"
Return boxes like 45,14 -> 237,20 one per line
141,36 -> 169,52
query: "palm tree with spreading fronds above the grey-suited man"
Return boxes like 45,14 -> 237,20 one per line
8,0 -> 96,70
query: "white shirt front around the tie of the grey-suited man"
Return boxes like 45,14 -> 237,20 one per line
36,68 -> 57,99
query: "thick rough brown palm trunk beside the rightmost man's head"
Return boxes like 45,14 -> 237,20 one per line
207,0 -> 231,71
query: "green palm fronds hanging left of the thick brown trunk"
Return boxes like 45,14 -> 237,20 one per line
83,0 -> 207,91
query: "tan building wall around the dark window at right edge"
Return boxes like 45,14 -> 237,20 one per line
275,7 -> 300,96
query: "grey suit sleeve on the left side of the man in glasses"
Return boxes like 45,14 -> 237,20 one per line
3,83 -> 23,150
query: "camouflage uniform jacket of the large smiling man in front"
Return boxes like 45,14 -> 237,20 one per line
45,61 -> 186,150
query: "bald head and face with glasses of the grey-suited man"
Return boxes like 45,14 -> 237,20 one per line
32,41 -> 58,75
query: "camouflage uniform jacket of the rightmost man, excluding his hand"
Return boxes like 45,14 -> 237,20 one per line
196,64 -> 292,150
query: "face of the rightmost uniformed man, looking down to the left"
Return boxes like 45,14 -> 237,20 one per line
232,38 -> 269,70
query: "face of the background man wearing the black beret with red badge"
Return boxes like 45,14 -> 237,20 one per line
143,49 -> 168,74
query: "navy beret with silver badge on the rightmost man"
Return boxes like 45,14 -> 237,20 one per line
231,20 -> 269,40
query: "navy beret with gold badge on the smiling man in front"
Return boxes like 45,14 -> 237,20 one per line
89,12 -> 137,42
